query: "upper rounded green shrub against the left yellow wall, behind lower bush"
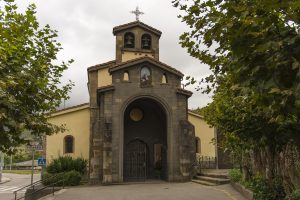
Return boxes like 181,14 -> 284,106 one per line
46,156 -> 87,174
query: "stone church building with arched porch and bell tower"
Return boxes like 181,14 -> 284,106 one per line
46,21 -> 215,184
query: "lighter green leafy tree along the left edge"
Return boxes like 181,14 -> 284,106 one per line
0,0 -> 73,152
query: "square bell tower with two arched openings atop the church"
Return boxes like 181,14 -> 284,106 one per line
113,18 -> 161,63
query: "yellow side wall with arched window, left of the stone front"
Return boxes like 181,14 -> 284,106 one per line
46,105 -> 90,163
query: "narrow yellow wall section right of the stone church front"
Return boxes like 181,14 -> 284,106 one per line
188,112 -> 216,156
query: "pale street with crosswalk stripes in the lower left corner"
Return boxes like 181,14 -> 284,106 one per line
0,173 -> 41,200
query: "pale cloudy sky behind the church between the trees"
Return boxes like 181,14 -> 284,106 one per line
16,0 -> 210,108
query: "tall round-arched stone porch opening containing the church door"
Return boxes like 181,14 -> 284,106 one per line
123,98 -> 167,181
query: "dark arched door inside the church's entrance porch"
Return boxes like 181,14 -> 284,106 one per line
124,140 -> 147,181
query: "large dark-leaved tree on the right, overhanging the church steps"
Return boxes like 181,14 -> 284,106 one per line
173,0 -> 300,194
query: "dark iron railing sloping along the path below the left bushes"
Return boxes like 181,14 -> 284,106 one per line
14,173 -> 65,200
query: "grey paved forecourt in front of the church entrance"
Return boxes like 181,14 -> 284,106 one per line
42,182 -> 245,200
